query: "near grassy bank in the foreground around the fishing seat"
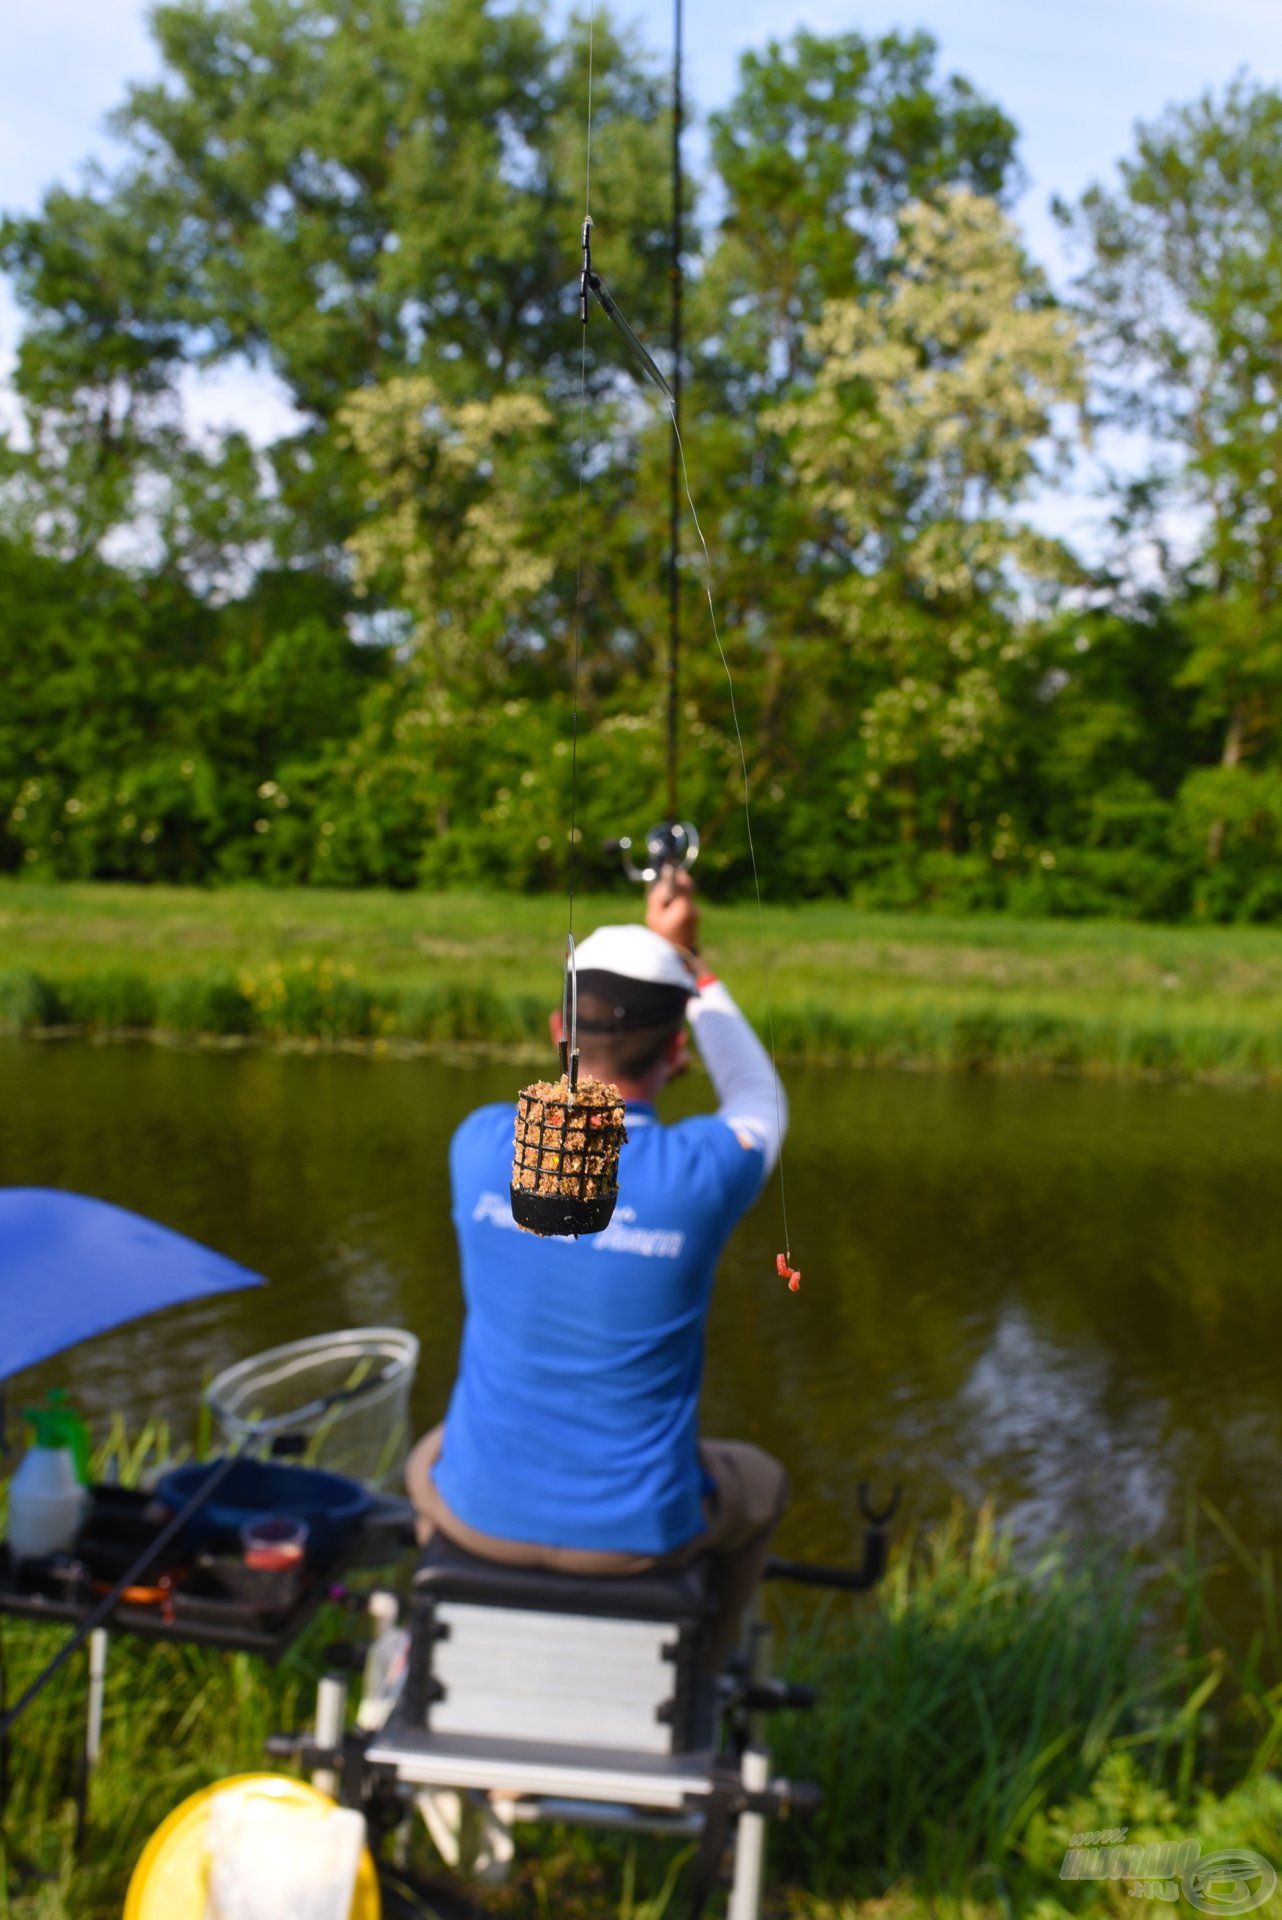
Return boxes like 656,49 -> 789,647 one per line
0,1459 -> 1282,1920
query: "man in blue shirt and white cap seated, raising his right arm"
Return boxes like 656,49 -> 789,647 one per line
407,868 -> 787,1661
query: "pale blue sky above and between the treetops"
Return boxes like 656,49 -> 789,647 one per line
0,0 -> 1282,541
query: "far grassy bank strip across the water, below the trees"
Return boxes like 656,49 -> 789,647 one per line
0,881 -> 1282,1081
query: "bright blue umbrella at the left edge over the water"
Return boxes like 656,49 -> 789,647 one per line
0,1187 -> 263,1379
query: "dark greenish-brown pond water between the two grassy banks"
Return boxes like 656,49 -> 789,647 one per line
0,1041 -> 1282,1597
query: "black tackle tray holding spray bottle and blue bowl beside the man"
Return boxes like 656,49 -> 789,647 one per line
0,1488 -> 415,1661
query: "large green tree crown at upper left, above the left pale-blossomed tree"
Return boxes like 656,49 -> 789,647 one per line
0,0 -> 666,570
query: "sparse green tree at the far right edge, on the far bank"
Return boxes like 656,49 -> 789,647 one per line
1059,77 -> 1282,798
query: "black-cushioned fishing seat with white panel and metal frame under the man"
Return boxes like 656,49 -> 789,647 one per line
296,1534 -> 819,1920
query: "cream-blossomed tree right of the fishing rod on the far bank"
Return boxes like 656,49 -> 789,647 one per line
770,188 -> 1082,847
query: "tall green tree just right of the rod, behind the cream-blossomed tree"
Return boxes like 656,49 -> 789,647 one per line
647,31 -> 1015,891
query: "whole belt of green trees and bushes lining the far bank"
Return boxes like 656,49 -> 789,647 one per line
0,11 -> 1282,913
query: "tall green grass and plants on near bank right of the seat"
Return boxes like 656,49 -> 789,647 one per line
775,1511 -> 1282,1916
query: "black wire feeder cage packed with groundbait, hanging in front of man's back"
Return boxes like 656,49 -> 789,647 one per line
512,1062 -> 628,1235
